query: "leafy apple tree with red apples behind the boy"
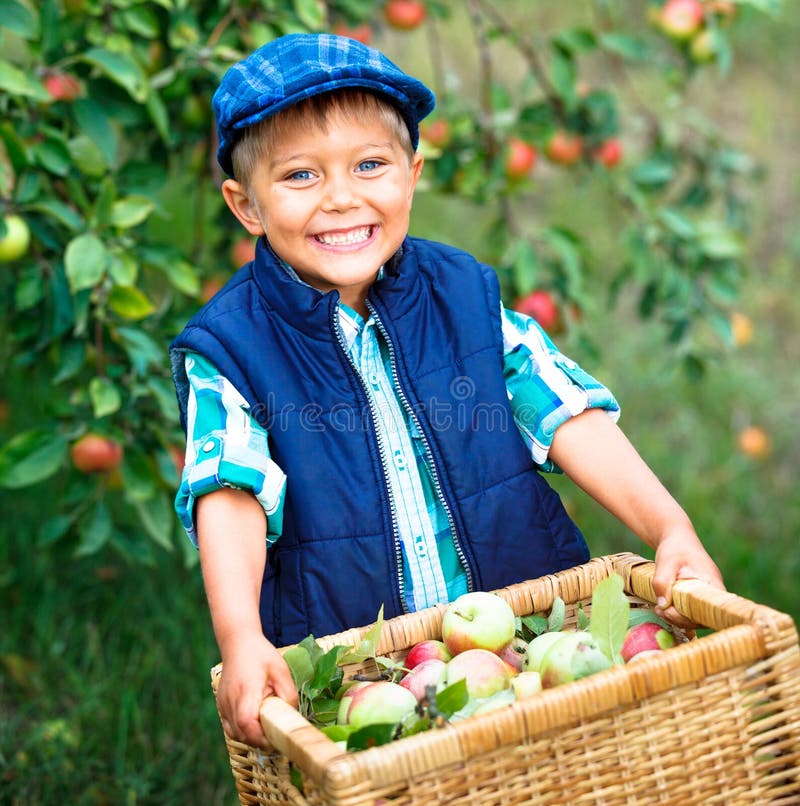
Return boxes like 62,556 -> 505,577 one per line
0,0 -> 777,562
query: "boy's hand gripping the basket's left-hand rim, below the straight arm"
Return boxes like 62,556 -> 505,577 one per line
217,635 -> 297,747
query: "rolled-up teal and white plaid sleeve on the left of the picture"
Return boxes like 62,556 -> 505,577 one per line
175,353 -> 286,546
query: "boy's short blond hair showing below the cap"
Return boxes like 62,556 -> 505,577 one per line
231,88 -> 414,191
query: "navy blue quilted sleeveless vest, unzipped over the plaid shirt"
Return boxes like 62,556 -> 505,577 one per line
171,238 -> 589,646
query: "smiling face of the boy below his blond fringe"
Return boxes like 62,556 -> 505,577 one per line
223,105 -> 422,313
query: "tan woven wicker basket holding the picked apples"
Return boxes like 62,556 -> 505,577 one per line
212,554 -> 800,806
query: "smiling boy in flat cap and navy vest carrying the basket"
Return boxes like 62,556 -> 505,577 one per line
172,35 -> 722,745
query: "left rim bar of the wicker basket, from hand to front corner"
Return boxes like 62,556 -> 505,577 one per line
259,697 -> 348,781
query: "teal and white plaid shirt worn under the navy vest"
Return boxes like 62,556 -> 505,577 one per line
175,304 -> 619,611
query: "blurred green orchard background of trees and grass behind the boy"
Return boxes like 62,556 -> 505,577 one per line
0,0 -> 800,805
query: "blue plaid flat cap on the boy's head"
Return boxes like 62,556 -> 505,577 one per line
212,34 -> 435,176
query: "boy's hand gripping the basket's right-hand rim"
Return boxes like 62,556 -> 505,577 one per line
653,528 -> 725,629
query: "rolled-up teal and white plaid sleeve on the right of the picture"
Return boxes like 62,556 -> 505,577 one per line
502,308 -> 620,472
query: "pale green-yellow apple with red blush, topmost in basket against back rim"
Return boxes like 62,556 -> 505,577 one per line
442,591 -> 516,662
